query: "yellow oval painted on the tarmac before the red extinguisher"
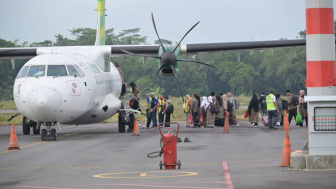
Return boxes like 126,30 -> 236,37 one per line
92,171 -> 199,178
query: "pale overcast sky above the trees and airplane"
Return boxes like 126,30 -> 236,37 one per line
0,0 -> 336,44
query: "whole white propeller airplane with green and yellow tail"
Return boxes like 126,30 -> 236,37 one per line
0,0 -> 306,141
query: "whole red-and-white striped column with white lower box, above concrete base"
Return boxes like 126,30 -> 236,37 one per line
305,0 -> 336,155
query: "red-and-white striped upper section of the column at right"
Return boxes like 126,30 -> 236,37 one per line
306,0 -> 336,96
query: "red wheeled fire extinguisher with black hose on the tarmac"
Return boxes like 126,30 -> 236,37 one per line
147,123 -> 181,169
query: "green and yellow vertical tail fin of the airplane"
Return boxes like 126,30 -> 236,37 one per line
95,0 -> 105,46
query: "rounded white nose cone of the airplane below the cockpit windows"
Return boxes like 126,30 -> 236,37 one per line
27,87 -> 62,122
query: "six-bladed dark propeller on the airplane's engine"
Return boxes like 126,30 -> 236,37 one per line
121,13 -> 216,102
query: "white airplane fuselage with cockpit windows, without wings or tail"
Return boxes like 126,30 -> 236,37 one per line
13,53 -> 122,125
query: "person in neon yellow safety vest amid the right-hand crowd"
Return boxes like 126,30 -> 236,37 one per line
266,91 -> 280,129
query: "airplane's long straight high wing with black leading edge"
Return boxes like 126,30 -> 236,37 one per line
0,39 -> 306,59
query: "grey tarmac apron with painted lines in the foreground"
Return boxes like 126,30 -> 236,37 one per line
0,121 -> 336,189
